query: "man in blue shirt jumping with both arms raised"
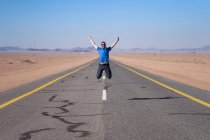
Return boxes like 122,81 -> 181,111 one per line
89,36 -> 119,79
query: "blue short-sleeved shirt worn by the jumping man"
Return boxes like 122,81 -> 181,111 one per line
97,47 -> 112,63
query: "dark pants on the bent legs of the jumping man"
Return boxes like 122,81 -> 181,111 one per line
96,64 -> 112,79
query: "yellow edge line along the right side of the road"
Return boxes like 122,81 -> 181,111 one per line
114,61 -> 210,108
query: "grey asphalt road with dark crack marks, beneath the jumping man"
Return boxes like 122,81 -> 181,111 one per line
0,59 -> 210,140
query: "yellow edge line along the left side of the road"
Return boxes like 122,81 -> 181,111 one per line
0,60 -> 95,109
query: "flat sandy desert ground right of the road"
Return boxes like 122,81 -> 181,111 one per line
111,52 -> 210,91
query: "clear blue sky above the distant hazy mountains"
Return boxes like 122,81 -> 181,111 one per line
0,0 -> 210,49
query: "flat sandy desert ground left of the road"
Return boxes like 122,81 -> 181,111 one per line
0,52 -> 97,92
